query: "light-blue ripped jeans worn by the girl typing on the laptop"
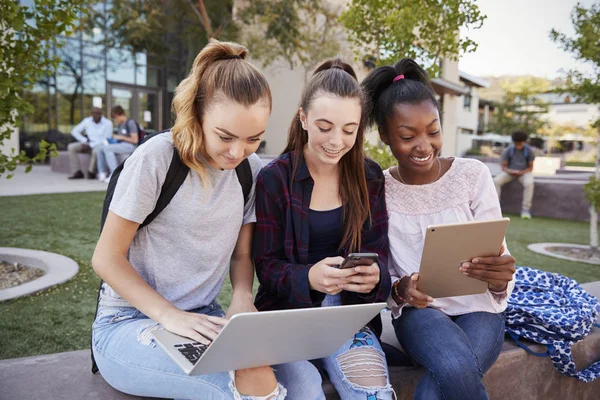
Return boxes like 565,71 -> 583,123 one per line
92,303 -> 325,400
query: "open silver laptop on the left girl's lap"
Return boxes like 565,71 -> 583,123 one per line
152,303 -> 387,375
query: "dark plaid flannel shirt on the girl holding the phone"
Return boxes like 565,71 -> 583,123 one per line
253,152 -> 391,334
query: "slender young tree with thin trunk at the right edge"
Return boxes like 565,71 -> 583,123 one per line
550,3 -> 600,252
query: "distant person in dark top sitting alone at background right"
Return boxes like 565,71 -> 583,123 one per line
494,131 -> 535,219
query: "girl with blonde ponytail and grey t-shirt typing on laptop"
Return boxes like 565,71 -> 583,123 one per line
92,40 -> 310,400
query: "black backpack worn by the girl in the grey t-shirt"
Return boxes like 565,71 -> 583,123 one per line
90,129 -> 252,374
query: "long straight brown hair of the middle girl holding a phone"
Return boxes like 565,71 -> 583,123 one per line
283,58 -> 371,252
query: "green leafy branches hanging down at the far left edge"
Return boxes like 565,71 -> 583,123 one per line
0,0 -> 84,178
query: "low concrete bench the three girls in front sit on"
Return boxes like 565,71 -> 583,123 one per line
0,281 -> 600,400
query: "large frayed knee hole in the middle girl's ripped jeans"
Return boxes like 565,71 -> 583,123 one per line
337,346 -> 388,388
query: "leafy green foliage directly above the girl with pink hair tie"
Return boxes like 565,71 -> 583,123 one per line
342,0 -> 486,76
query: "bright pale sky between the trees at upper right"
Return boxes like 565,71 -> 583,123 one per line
458,0 -> 598,79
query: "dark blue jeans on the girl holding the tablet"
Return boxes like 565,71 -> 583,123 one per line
392,307 -> 504,400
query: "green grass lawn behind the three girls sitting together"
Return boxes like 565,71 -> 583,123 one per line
0,192 -> 600,359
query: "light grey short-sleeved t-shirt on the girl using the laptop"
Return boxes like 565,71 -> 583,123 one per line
103,133 -> 262,310
